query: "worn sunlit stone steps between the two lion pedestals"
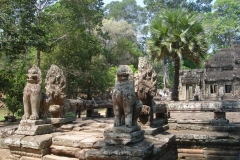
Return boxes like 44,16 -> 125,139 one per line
43,120 -> 111,160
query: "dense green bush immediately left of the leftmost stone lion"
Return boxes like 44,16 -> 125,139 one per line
0,54 -> 33,115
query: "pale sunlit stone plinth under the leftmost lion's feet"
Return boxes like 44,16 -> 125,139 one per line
15,120 -> 56,136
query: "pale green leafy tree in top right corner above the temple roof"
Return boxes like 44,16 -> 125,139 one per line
204,0 -> 240,50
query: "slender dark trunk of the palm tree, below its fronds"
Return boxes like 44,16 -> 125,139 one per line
172,53 -> 180,101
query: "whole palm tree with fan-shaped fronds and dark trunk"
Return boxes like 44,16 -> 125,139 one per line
147,9 -> 208,101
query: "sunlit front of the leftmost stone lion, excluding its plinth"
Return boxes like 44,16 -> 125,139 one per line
22,65 -> 42,120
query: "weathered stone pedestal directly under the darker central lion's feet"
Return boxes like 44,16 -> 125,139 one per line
104,126 -> 144,145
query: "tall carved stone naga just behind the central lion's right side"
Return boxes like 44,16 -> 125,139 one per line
135,57 -> 157,125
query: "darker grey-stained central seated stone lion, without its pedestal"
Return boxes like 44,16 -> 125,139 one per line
112,65 -> 142,127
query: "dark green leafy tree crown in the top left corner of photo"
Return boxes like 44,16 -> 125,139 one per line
0,0 -> 49,65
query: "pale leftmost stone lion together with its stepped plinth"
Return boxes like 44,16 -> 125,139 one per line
15,65 -> 55,135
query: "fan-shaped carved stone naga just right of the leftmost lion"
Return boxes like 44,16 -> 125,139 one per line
45,65 -> 66,118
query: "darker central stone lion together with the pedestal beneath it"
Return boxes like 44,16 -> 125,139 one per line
104,65 -> 144,145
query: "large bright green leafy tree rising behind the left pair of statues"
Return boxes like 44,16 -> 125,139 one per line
42,0 -> 107,99
